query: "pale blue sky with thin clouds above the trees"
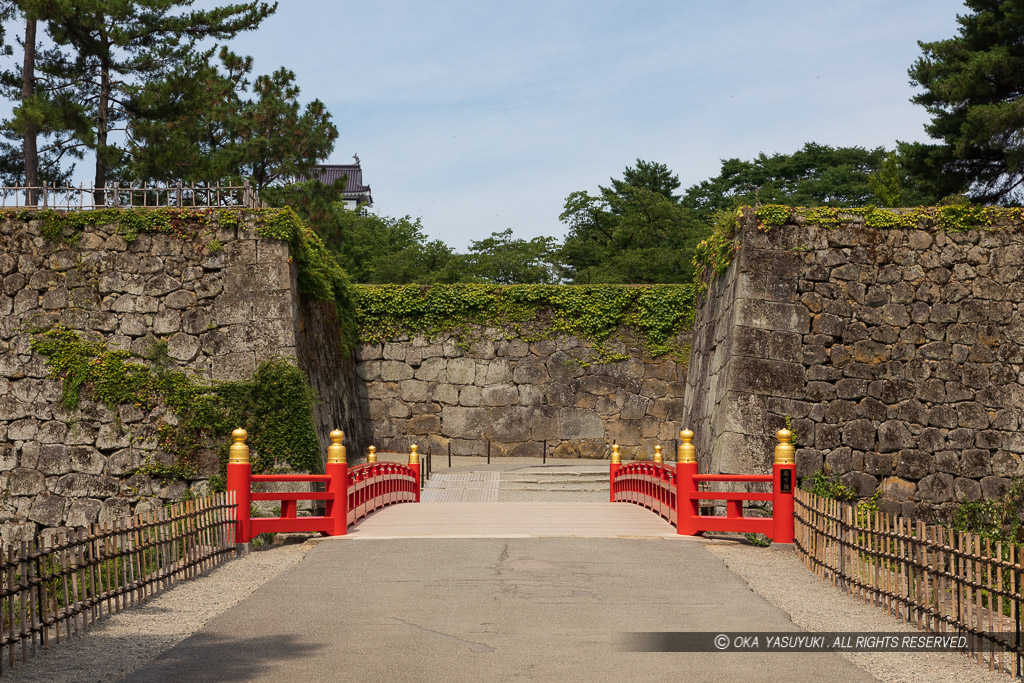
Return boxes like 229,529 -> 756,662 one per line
28,0 -> 964,250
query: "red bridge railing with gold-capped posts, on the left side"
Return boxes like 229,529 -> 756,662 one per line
227,429 -> 420,543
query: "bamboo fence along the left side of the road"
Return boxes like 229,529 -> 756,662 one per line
0,494 -> 236,671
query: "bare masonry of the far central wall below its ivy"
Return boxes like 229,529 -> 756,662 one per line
356,329 -> 685,458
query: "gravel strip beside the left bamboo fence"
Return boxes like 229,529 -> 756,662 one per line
3,544 -> 312,683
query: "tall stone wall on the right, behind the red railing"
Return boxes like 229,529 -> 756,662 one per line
684,215 -> 1024,516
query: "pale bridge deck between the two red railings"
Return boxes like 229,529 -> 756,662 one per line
334,503 -> 688,540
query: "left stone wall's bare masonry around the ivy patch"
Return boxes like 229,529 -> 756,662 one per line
0,210 -> 359,542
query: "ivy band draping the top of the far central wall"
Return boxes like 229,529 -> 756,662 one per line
353,284 -> 694,362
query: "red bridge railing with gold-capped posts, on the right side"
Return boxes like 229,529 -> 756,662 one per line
609,429 -> 797,543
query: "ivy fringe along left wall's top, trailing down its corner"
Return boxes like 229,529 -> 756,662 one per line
18,207 -> 357,348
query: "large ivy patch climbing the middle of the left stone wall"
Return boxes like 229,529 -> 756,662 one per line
31,326 -> 319,478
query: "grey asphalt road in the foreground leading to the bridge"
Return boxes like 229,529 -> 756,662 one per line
119,539 -> 873,683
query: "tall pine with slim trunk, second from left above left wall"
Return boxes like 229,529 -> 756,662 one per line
37,0 -> 276,203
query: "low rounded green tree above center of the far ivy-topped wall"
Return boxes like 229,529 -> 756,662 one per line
465,228 -> 558,285
